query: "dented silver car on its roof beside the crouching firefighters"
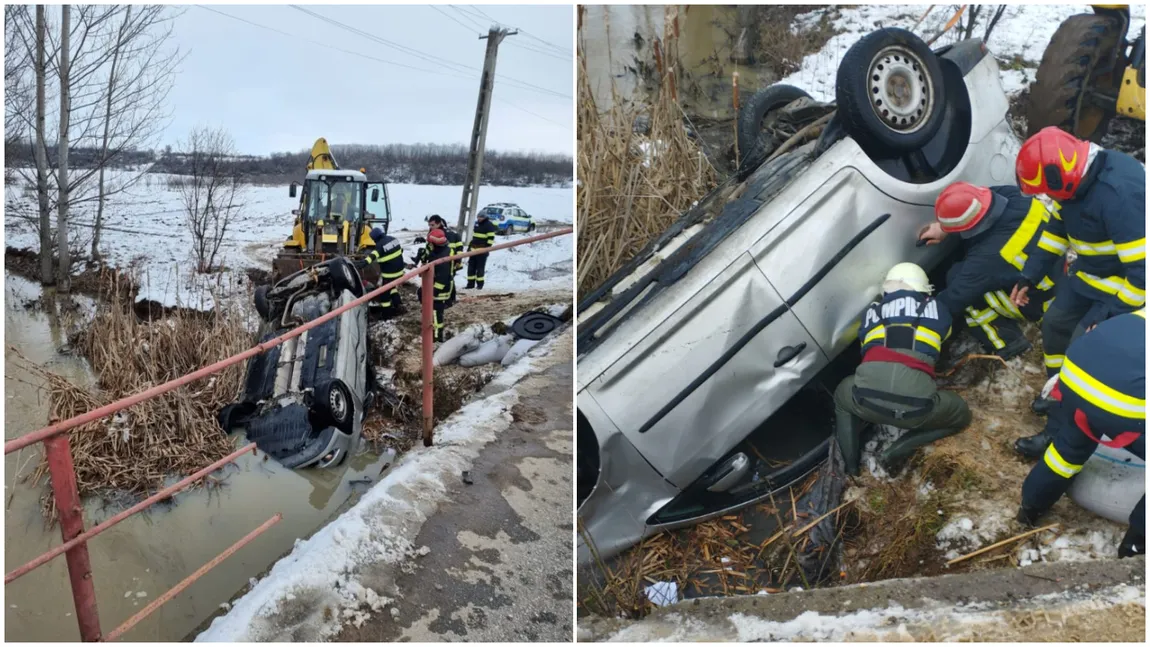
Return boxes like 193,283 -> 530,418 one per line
576,29 -> 1019,562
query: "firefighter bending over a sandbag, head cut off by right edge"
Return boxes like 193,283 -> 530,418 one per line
1018,308 -> 1147,557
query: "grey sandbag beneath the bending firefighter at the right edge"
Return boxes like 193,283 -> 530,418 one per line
1067,445 -> 1147,524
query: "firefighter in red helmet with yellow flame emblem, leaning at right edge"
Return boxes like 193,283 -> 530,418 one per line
1011,126 -> 1147,414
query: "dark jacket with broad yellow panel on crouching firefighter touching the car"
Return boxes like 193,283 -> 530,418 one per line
935,186 -> 1053,319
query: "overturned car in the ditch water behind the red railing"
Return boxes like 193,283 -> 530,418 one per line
220,257 -> 371,469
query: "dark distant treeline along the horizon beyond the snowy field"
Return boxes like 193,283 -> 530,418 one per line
5,141 -> 573,186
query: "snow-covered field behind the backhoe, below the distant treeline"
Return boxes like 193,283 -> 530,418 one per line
5,174 -> 574,309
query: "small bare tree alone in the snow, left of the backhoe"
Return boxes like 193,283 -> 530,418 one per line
177,126 -> 243,272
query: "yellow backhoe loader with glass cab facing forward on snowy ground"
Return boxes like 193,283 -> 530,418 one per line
273,137 -> 391,280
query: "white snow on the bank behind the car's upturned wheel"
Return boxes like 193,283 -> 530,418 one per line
780,5 -> 1145,101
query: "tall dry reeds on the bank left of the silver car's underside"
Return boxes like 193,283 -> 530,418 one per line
577,11 -> 715,296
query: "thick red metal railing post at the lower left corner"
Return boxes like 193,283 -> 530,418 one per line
44,433 -> 100,642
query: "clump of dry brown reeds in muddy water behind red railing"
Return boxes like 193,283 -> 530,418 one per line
15,272 -> 252,519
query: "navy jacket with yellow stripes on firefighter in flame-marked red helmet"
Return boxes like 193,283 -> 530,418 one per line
1022,151 -> 1147,316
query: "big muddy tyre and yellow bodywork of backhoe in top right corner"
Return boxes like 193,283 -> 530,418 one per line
1027,5 -> 1147,144
